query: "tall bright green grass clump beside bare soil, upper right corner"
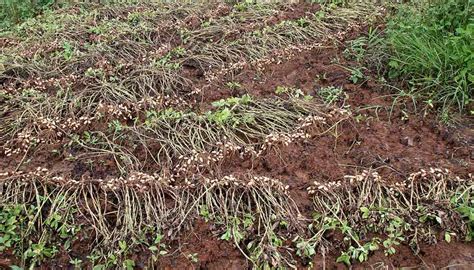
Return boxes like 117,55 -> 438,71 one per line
387,0 -> 474,111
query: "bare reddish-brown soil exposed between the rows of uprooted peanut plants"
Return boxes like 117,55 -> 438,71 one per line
0,2 -> 474,269
